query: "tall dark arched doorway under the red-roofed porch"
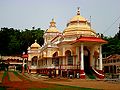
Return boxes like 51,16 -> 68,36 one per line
84,47 -> 90,74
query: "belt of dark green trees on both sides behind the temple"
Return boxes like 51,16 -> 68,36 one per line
0,27 -> 120,56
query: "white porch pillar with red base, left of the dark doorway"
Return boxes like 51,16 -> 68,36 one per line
80,43 -> 85,79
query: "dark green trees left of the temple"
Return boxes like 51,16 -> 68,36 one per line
0,28 -> 44,55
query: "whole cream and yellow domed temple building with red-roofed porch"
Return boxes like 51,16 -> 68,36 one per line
27,9 -> 106,79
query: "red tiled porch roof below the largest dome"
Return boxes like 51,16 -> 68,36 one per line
76,37 -> 107,43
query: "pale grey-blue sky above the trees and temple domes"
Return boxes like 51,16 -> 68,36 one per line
0,0 -> 120,36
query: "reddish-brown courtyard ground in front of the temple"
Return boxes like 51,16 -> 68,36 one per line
0,71 -> 120,90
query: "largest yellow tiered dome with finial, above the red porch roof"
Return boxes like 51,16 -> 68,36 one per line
63,8 -> 96,36
